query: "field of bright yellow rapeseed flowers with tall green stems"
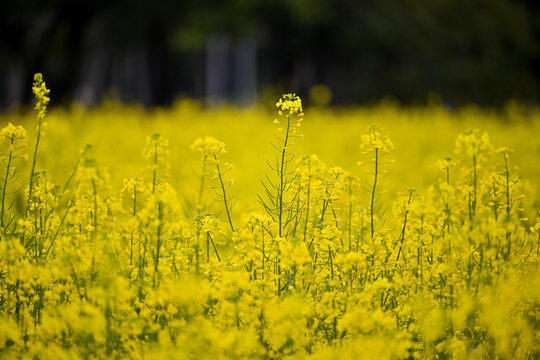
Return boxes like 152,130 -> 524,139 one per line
0,74 -> 540,359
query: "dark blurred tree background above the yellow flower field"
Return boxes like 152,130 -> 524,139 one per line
0,0 -> 540,110
